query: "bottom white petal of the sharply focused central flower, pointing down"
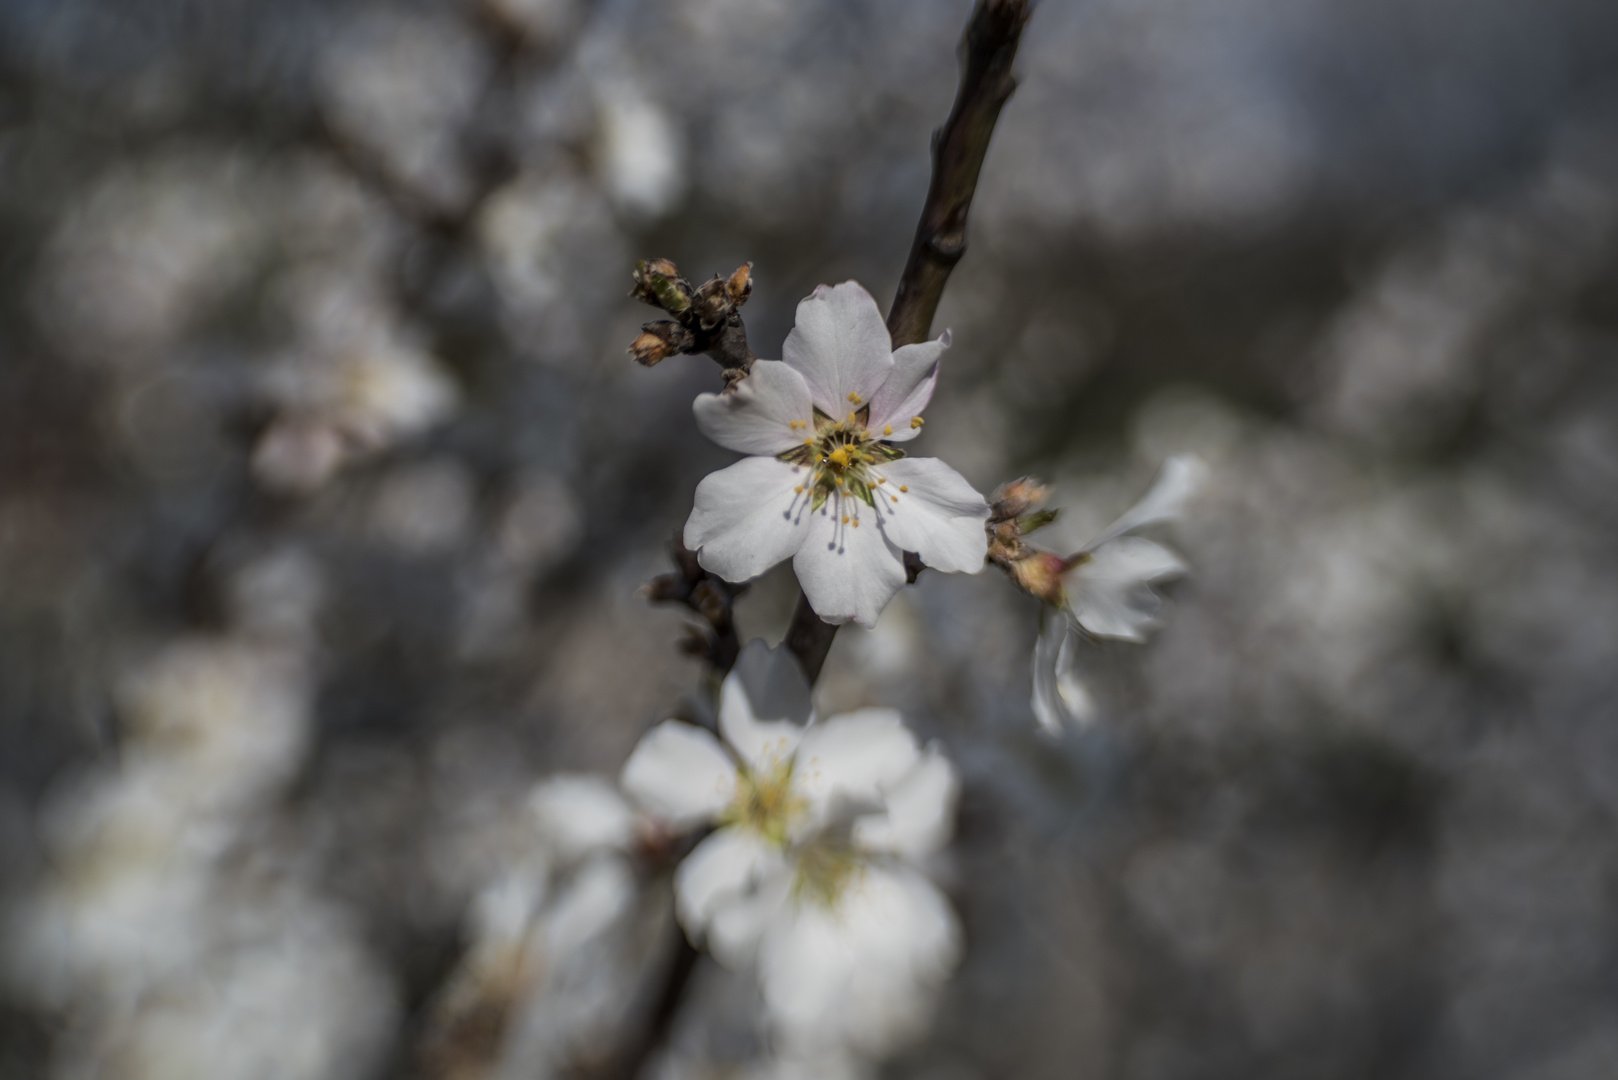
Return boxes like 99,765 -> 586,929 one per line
792,495 -> 904,627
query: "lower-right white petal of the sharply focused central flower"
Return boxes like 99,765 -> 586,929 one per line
874,458 -> 989,573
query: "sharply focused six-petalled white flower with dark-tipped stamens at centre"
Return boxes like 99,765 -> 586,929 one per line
684,282 -> 989,627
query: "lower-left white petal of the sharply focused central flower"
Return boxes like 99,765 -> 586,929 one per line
684,457 -> 809,581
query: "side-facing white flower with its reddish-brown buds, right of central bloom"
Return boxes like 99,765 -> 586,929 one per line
990,455 -> 1205,733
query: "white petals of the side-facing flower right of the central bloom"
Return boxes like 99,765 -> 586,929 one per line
1031,455 -> 1205,735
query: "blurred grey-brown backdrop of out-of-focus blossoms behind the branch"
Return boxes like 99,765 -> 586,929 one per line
0,0 -> 1618,1080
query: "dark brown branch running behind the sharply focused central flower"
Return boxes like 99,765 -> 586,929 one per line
786,0 -> 1032,685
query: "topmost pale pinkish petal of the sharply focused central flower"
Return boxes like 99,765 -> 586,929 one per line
781,282 -> 893,418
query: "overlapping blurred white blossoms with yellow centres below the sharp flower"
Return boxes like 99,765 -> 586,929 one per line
623,643 -> 959,1054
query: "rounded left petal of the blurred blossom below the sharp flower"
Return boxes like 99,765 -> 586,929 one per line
621,721 -> 736,826
